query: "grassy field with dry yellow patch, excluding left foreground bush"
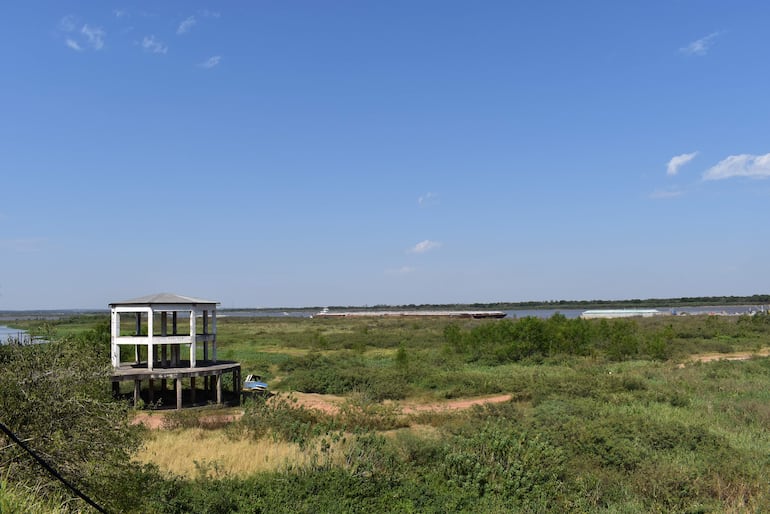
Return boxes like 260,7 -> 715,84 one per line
6,315 -> 770,512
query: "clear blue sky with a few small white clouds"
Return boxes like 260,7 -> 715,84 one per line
0,0 -> 770,309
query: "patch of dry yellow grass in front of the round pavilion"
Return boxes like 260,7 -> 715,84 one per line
135,428 -> 344,478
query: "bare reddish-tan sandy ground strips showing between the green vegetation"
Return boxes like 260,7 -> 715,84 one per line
132,348 -> 770,430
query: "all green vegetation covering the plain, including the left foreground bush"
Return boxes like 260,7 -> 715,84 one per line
0,314 -> 770,513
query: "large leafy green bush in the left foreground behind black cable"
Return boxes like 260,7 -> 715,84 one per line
0,331 -> 146,511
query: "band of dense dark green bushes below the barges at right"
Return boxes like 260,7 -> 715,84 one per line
443,314 -> 770,366
